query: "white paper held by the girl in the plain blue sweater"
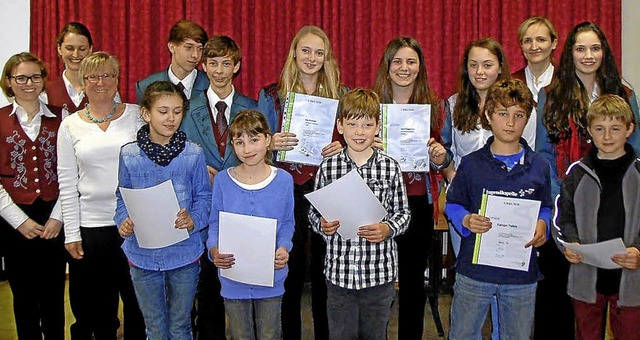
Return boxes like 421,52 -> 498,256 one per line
218,211 -> 278,287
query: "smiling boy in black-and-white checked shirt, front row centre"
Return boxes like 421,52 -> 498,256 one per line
309,89 -> 410,339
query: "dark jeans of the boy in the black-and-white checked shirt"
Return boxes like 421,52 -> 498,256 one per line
327,281 -> 395,340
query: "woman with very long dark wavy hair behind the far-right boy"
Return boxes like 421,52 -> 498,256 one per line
536,22 -> 640,338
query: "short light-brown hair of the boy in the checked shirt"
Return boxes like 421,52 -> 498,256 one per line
338,88 -> 380,122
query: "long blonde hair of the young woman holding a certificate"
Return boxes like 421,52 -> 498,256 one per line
278,26 -> 341,99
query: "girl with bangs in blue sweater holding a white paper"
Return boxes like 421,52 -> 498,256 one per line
207,110 -> 294,339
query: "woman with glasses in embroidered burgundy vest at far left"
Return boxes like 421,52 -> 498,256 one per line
0,52 -> 66,339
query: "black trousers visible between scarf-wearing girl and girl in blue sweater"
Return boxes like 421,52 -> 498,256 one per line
194,249 -> 226,340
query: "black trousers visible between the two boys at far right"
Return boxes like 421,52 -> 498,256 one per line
533,240 -> 575,340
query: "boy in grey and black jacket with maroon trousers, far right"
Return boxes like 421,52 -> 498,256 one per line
554,94 -> 640,339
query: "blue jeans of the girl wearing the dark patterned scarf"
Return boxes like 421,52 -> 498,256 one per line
130,262 -> 200,340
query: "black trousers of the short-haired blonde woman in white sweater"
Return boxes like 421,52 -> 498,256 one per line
69,226 -> 146,340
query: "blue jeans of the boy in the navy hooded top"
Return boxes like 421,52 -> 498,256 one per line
449,274 -> 537,340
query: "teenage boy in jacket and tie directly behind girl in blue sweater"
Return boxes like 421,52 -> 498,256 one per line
180,35 -> 257,339
